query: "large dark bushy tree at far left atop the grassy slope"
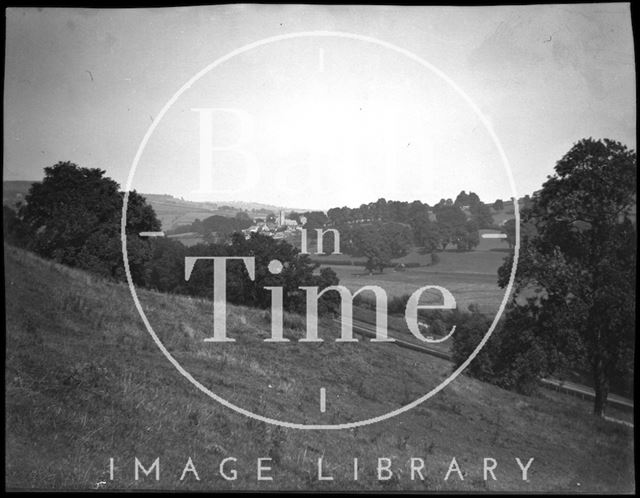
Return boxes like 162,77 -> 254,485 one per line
18,162 -> 160,283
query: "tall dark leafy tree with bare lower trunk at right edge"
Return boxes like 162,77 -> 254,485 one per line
499,138 -> 637,416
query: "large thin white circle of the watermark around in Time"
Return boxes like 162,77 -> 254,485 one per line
120,31 -> 520,430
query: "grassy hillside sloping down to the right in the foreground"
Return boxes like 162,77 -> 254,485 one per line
4,245 -> 635,492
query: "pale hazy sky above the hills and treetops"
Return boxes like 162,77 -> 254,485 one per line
4,4 -> 636,209
